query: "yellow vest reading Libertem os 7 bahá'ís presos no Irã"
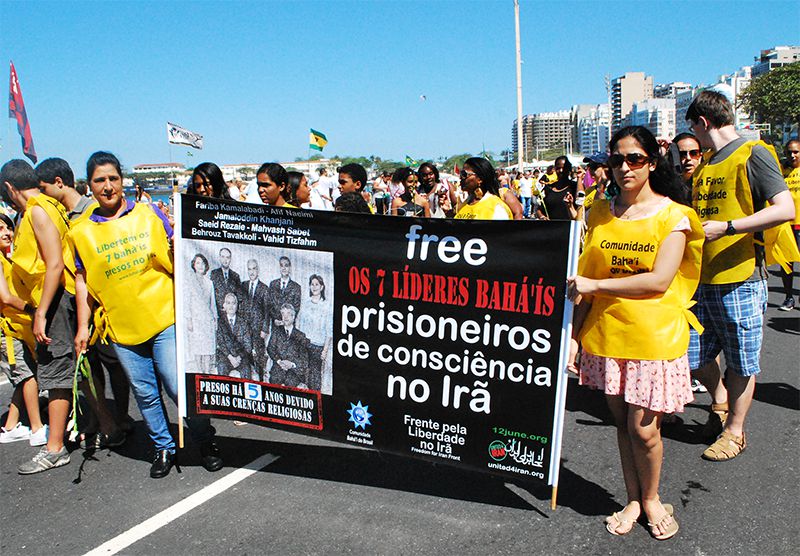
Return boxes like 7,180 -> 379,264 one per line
67,203 -> 175,345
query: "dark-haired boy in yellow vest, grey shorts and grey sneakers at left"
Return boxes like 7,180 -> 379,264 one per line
0,160 -> 75,475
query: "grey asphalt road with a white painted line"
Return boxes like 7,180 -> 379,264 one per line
0,272 -> 800,556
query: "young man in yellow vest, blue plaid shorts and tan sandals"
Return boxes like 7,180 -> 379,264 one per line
686,90 -> 794,461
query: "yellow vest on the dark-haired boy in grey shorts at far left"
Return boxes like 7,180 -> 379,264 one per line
9,194 -> 75,307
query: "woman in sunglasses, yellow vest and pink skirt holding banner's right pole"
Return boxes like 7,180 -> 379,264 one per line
567,126 -> 704,540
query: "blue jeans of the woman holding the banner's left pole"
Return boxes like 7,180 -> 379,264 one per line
112,325 -> 214,452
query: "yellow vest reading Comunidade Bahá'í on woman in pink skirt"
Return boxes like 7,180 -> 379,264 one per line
578,199 -> 705,360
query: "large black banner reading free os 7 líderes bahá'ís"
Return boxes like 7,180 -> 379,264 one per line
175,195 -> 575,484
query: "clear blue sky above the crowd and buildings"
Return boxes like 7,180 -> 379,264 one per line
0,0 -> 800,176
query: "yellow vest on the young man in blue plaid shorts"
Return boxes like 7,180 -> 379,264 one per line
692,141 -> 800,284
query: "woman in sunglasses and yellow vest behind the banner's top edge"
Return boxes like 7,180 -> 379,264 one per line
455,157 -> 513,220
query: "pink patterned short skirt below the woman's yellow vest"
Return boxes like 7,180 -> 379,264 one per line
580,351 -> 694,413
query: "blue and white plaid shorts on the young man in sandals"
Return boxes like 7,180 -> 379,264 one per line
689,280 -> 767,376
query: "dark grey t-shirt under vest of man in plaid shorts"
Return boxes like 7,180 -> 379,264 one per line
709,137 -> 789,282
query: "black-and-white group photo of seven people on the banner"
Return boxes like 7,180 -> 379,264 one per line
178,241 -> 333,395
